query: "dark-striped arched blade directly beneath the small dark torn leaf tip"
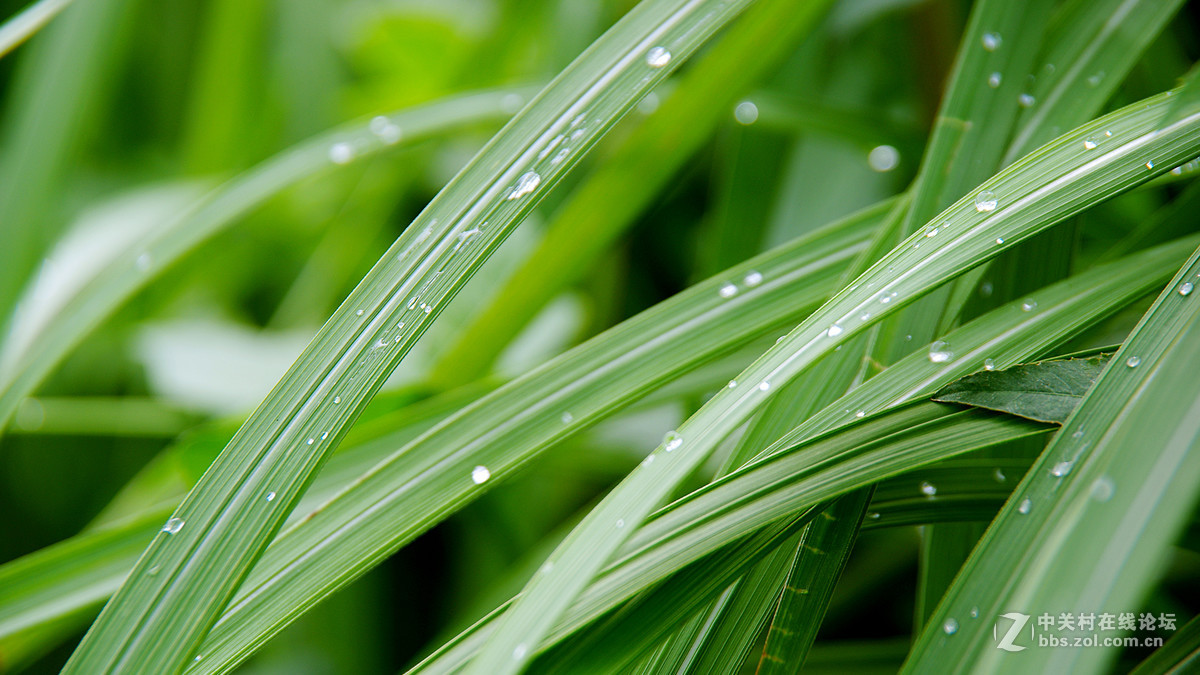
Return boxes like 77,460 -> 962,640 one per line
410,402 -> 1048,674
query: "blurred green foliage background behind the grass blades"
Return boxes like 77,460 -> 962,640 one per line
0,0 -> 1200,674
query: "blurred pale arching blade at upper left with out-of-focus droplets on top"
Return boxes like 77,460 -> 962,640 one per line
0,91 -> 525,430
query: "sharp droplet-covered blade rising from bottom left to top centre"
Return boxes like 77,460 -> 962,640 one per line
65,0 -> 758,673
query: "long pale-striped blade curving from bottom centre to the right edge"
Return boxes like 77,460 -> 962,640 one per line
460,95 -> 1200,671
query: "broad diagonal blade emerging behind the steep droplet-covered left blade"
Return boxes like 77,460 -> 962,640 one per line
190,196 -> 892,673
